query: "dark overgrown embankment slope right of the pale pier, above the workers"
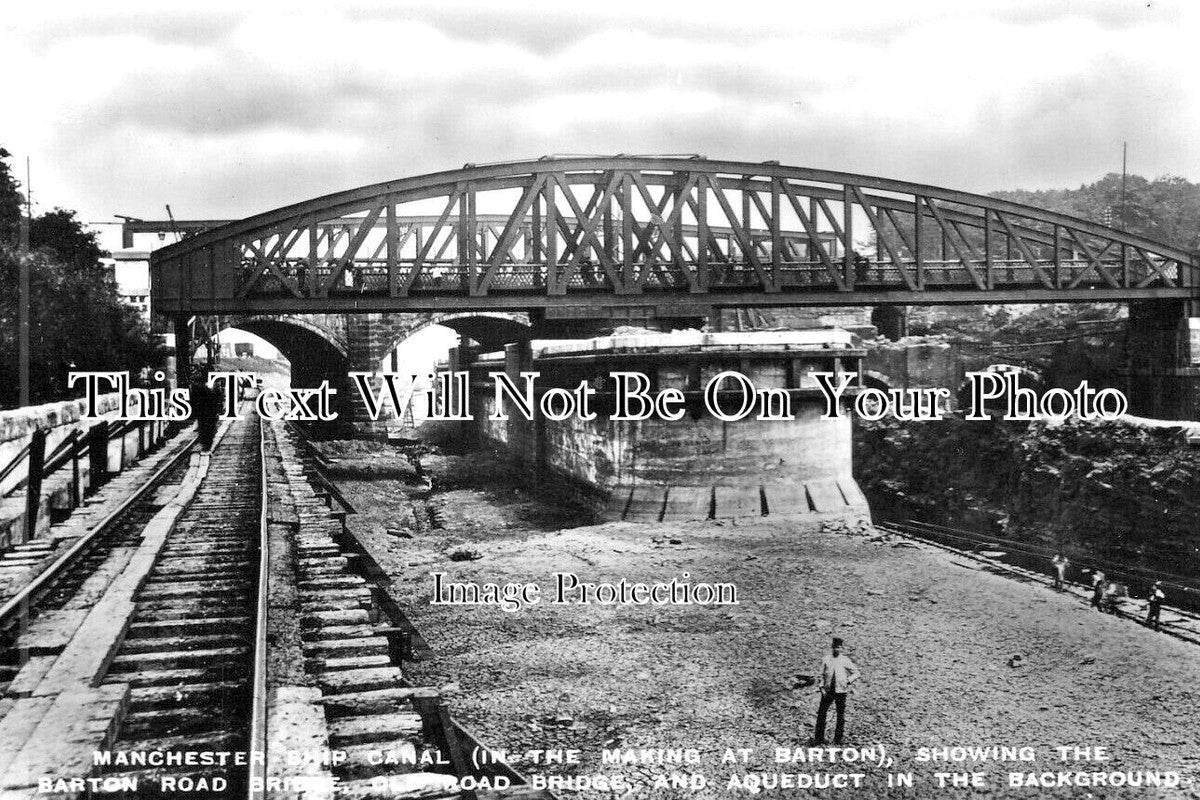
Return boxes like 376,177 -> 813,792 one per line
854,420 -> 1200,576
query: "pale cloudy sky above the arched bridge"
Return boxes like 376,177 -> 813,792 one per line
0,0 -> 1200,221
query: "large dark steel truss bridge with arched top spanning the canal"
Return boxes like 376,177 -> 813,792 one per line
151,156 -> 1200,318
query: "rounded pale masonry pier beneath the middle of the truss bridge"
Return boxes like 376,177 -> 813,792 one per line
472,335 -> 869,521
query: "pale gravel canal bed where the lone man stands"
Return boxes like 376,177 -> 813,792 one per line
319,443 -> 1200,799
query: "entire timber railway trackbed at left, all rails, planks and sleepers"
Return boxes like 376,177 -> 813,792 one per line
0,415 -> 553,800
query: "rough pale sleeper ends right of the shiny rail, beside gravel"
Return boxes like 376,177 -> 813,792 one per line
269,425 -> 554,800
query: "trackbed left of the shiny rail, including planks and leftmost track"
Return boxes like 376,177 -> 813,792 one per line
0,419 -> 262,799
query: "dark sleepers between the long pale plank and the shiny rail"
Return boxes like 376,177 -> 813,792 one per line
103,417 -> 263,796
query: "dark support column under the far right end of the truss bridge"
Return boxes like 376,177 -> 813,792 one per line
1126,301 -> 1200,420
